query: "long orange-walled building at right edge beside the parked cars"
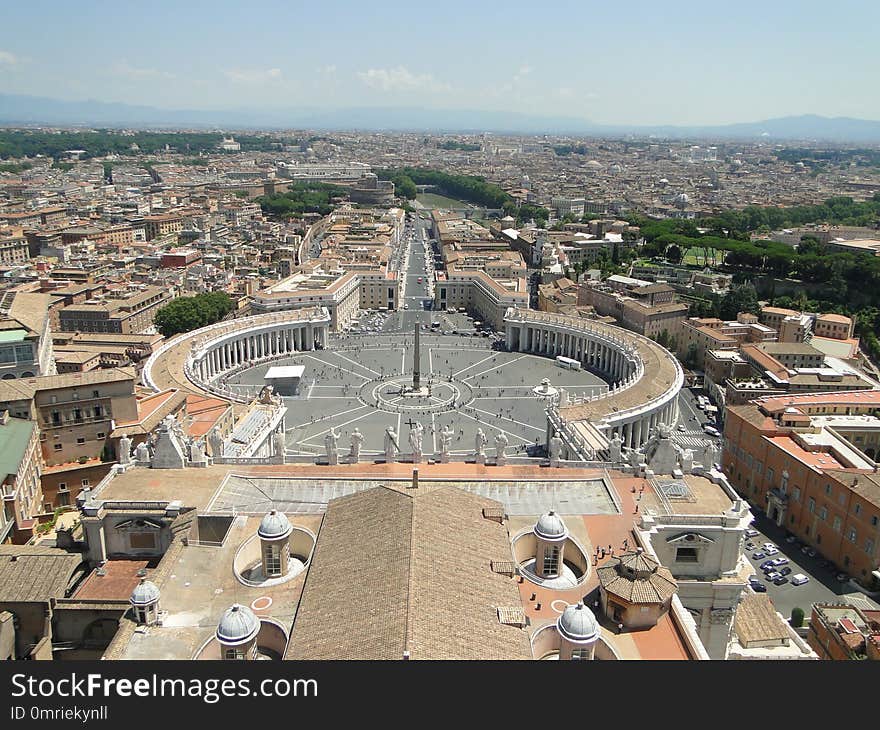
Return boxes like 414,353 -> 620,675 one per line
722,391 -> 880,590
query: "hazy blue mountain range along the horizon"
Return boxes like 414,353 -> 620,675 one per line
0,94 -> 880,144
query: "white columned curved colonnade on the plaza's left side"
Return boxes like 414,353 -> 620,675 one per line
143,307 -> 330,403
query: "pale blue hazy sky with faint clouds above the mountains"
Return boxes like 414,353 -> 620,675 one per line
0,0 -> 880,124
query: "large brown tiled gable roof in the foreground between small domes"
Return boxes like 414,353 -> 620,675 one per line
286,485 -> 531,659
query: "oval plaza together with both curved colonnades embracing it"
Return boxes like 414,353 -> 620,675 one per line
144,307 -> 683,462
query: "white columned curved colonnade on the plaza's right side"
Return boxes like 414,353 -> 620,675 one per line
504,309 -> 684,460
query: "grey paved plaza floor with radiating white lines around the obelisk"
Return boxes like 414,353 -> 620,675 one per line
227,331 -> 607,459
